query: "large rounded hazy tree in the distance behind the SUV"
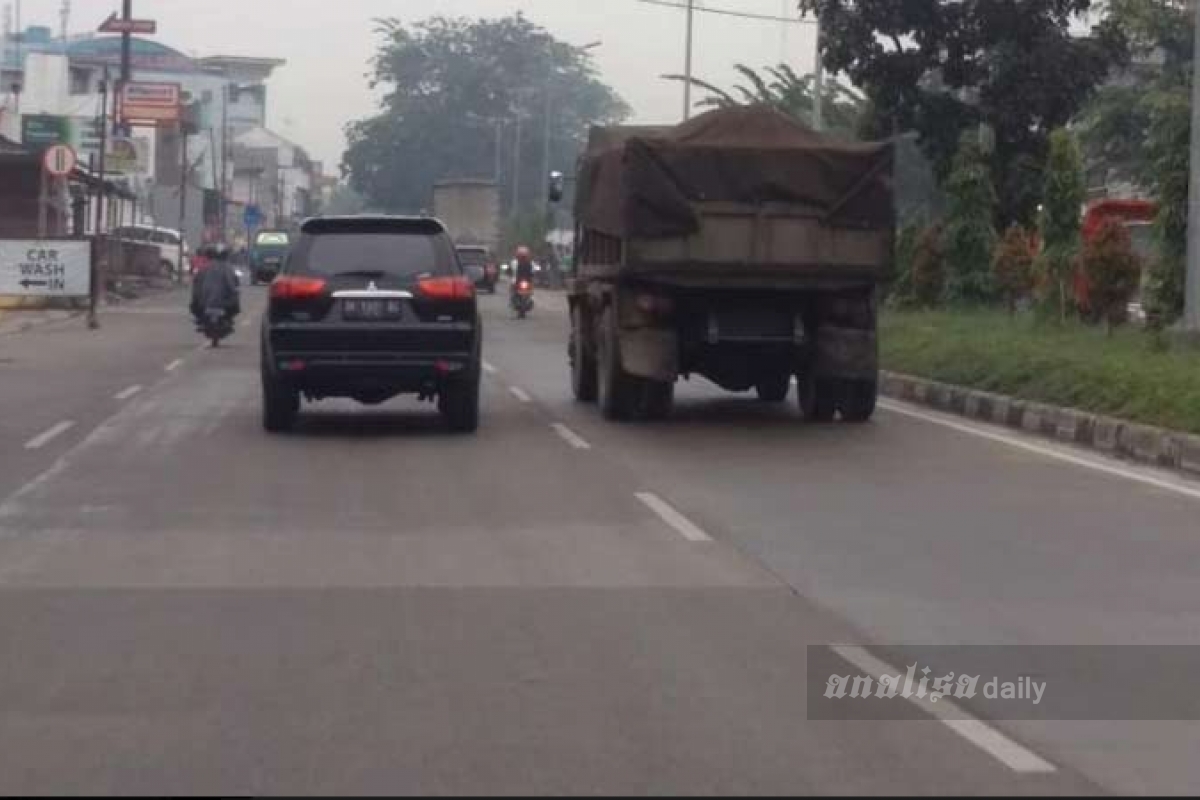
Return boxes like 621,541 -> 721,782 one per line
342,13 -> 629,211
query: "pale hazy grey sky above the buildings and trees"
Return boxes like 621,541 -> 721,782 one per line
30,0 -> 814,167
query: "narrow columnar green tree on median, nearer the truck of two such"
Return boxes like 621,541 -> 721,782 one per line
942,133 -> 996,303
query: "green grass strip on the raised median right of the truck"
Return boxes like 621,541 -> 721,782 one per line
880,311 -> 1200,433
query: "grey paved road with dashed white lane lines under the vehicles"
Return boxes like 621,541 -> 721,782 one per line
0,290 -> 1200,794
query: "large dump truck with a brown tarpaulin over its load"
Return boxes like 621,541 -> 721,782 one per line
551,107 -> 895,422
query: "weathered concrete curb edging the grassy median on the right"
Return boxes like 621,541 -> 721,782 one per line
880,372 -> 1200,477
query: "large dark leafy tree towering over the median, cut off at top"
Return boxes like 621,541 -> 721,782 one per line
800,0 -> 1126,228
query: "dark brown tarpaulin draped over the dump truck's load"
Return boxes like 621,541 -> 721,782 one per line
576,107 -> 894,239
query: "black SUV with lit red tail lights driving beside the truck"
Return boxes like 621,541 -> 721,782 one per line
262,216 -> 482,432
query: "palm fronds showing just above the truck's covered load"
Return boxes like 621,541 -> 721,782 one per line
662,64 -> 866,139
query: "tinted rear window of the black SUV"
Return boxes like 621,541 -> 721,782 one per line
287,231 -> 457,278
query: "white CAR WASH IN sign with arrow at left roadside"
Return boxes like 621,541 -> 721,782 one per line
0,239 -> 91,297
